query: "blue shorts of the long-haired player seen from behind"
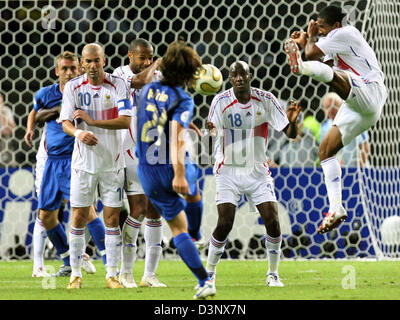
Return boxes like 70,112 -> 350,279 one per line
137,163 -> 198,221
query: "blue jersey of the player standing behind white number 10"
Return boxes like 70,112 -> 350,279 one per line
33,83 -> 75,156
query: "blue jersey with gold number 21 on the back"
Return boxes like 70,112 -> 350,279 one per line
136,81 -> 194,165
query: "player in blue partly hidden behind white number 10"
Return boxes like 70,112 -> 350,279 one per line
25,51 -> 104,276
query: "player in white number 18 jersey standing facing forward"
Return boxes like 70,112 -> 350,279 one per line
206,61 -> 301,287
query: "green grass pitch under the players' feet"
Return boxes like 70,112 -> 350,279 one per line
0,260 -> 400,301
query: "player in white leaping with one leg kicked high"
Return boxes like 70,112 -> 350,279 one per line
285,6 -> 387,233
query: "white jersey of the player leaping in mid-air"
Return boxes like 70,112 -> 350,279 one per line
316,26 -> 384,84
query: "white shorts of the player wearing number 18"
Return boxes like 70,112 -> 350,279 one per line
215,166 -> 277,207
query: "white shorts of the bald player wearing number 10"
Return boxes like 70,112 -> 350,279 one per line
70,169 -> 124,208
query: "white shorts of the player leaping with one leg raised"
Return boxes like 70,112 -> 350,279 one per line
333,71 -> 387,146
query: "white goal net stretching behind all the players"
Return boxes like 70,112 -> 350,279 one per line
0,0 -> 400,259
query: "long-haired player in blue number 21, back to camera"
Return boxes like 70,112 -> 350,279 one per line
136,42 -> 216,299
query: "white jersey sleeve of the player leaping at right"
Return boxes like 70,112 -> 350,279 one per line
315,28 -> 352,55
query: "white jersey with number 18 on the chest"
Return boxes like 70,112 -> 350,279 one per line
208,87 -> 289,173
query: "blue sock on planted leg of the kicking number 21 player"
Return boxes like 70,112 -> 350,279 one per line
174,233 -> 209,287
